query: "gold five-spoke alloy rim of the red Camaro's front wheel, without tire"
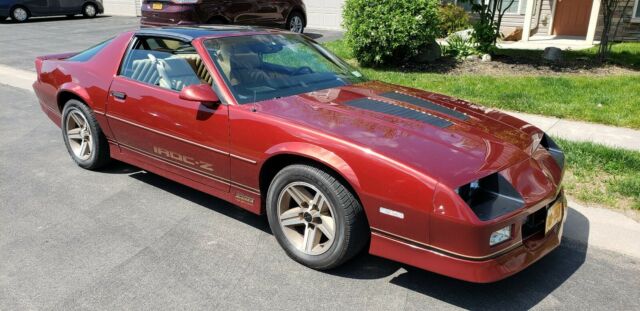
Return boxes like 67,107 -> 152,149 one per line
278,182 -> 336,255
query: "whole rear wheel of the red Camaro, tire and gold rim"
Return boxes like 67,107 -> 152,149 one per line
61,99 -> 110,170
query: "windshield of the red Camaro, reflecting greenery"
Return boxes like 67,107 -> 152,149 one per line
204,34 -> 365,104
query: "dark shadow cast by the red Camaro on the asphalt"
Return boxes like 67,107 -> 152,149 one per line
111,162 -> 589,310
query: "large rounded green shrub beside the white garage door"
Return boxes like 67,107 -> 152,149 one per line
343,0 -> 440,66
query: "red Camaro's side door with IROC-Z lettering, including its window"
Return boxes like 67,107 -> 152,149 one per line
106,37 -> 230,191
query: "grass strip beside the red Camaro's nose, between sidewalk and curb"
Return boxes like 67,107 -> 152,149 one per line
555,138 -> 640,210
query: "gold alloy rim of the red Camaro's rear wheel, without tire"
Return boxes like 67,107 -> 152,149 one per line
65,110 -> 94,161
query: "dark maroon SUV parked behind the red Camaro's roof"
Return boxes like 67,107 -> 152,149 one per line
141,0 -> 307,33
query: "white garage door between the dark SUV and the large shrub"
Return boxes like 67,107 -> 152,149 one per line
304,0 -> 344,29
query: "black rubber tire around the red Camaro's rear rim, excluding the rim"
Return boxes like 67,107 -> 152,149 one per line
60,99 -> 111,170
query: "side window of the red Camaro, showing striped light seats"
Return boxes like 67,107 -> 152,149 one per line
119,37 -> 213,91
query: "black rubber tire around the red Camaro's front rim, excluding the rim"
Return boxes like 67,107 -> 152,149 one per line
266,164 -> 370,270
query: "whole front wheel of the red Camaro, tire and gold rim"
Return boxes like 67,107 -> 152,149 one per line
267,164 -> 369,270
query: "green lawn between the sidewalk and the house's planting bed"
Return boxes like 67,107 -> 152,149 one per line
325,41 -> 640,129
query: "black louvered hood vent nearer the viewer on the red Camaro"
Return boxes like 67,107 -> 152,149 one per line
343,98 -> 453,128
